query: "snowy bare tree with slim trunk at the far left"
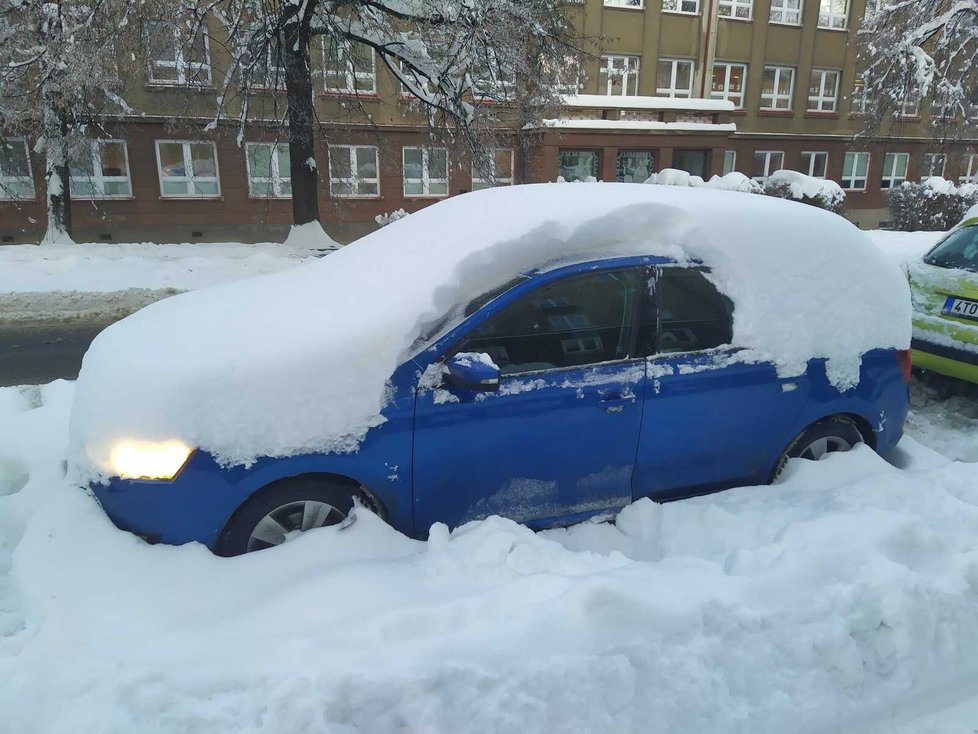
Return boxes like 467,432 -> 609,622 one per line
0,0 -> 165,243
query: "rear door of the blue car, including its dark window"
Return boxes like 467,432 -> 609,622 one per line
635,266 -> 809,499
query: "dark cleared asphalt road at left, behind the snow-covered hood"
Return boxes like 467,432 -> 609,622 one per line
0,321 -> 107,387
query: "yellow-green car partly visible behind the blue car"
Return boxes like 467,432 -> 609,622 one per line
908,218 -> 978,383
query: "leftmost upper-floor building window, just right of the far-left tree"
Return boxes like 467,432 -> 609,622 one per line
143,20 -> 211,86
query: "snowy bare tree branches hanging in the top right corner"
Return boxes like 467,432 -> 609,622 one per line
856,0 -> 978,137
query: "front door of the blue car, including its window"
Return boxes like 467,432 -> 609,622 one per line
413,268 -> 647,532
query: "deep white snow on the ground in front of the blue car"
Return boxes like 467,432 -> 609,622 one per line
0,382 -> 978,734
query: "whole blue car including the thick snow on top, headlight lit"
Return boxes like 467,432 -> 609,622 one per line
71,184 -> 910,555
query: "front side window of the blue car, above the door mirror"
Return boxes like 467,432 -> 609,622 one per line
458,268 -> 645,375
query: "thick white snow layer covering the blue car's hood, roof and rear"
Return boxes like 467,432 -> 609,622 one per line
71,184 -> 910,477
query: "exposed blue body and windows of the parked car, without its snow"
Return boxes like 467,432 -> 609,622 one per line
87,253 -> 910,556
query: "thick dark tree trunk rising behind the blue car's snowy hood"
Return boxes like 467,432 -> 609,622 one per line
284,20 -> 319,225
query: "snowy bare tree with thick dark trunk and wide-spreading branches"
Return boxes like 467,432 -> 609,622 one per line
191,0 -> 582,224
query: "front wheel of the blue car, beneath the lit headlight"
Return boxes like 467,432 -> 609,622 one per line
217,476 -> 359,556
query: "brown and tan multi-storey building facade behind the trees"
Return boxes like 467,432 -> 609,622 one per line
0,0 -> 978,243
